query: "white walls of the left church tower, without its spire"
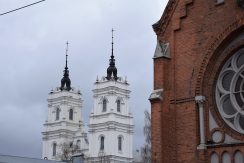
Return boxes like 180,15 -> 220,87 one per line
42,88 -> 88,160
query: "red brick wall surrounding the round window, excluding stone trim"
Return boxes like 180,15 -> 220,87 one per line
152,0 -> 244,163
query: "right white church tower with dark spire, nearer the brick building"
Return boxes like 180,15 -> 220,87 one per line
89,30 -> 133,163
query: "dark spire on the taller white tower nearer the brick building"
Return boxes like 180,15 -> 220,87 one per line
106,29 -> 118,80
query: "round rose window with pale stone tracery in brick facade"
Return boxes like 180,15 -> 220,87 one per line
216,49 -> 244,134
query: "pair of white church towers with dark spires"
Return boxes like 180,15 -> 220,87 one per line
42,30 -> 134,163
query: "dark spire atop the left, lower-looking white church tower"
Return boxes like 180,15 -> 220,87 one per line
60,42 -> 71,91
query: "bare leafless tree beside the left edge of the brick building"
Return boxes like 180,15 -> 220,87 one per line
141,110 -> 152,163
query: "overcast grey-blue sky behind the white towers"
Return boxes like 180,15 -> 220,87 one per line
0,0 -> 167,158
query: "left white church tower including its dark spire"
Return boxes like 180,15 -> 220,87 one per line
42,43 -> 88,160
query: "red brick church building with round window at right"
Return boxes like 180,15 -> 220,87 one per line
150,0 -> 244,163
